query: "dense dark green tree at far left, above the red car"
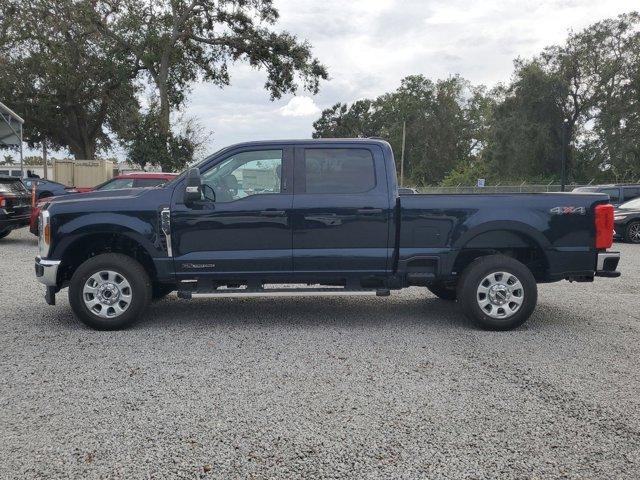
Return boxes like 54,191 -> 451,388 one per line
0,0 -> 140,158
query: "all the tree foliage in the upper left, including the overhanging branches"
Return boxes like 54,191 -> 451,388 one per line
0,0 -> 327,166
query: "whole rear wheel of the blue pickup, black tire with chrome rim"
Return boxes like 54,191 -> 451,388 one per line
458,255 -> 538,330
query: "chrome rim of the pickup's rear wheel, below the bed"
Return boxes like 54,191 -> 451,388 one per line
476,272 -> 524,319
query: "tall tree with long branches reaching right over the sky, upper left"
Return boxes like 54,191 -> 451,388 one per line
94,0 -> 327,169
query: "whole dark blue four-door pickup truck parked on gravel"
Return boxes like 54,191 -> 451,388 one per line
36,139 -> 619,330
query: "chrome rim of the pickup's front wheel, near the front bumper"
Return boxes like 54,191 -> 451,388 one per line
82,270 -> 133,318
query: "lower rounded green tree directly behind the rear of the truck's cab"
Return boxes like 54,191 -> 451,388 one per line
313,75 -> 488,185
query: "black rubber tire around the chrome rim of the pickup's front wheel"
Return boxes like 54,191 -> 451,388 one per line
69,253 -> 151,330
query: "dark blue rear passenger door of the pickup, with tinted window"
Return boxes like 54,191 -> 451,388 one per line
293,144 -> 392,273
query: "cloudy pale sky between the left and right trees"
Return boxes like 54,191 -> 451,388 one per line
185,0 -> 640,156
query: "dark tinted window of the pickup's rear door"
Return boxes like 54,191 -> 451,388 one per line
304,148 -> 376,193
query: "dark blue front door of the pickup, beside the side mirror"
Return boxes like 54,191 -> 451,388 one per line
171,147 -> 293,279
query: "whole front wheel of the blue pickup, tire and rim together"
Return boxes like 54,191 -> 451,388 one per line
69,253 -> 151,330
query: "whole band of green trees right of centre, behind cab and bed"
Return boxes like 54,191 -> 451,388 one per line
314,12 -> 640,185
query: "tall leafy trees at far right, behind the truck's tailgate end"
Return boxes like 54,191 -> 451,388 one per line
483,13 -> 640,185
